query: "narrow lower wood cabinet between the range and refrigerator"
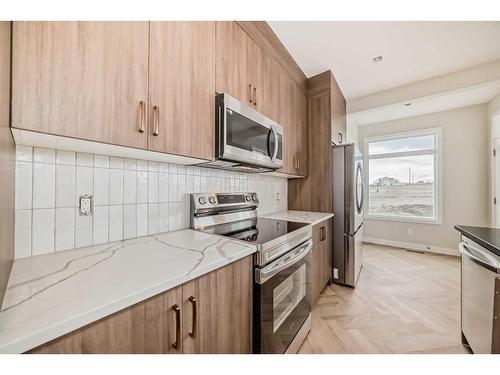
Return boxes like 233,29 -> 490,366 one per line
311,219 -> 332,303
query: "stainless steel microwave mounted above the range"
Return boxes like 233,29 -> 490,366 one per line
201,94 -> 283,172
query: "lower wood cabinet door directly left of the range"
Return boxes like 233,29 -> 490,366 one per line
182,256 -> 253,353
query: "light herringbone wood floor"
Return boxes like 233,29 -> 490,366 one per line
299,244 -> 468,354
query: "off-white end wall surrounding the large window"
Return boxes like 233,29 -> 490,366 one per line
359,104 -> 489,252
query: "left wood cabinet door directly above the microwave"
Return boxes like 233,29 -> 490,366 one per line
215,21 -> 252,105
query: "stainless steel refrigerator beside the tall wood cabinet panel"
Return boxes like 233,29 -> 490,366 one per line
332,144 -> 364,287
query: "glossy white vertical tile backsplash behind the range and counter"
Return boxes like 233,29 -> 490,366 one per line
15,146 -> 287,258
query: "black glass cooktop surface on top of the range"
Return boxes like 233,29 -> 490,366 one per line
203,218 -> 308,245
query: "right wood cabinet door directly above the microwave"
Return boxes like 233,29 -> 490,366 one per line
248,39 -> 278,121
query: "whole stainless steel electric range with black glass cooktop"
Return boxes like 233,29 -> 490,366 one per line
191,193 -> 313,353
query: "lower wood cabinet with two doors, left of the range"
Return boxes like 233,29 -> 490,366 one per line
29,256 -> 253,354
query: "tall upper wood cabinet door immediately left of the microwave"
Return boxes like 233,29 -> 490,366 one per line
149,22 -> 215,160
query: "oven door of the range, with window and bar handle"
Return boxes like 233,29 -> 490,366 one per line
254,240 -> 313,353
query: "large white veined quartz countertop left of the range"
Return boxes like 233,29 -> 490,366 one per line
0,229 -> 257,353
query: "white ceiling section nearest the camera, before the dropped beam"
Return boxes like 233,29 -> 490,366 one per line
269,21 -> 500,99
